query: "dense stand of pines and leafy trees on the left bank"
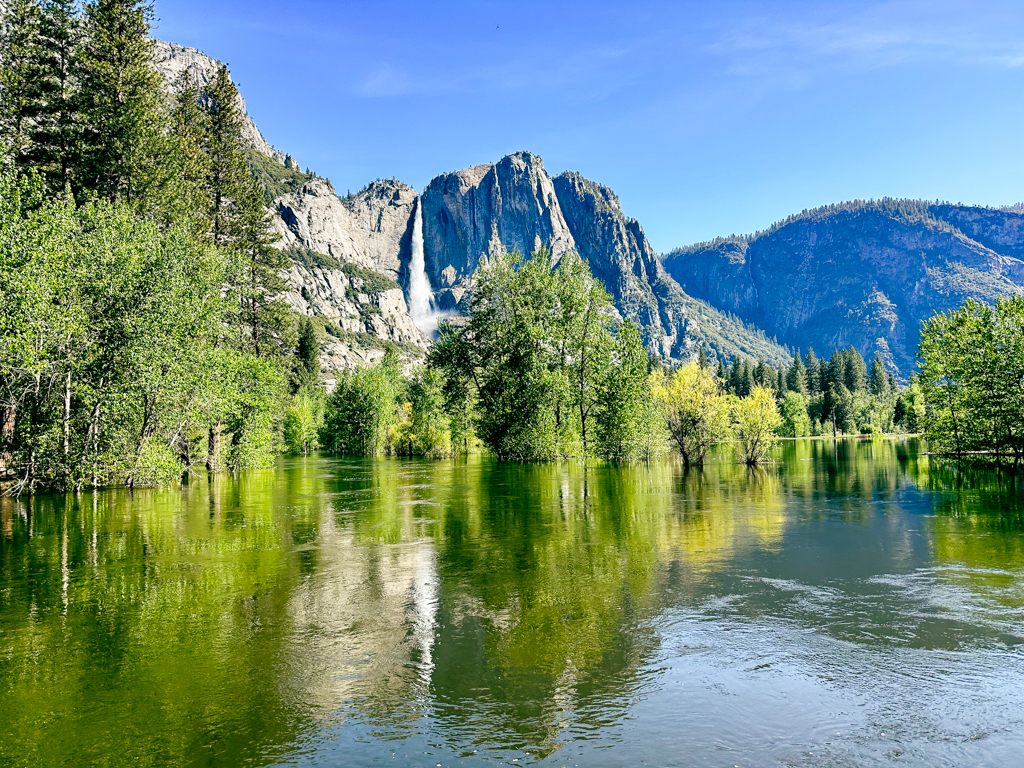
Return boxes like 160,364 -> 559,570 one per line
0,0 -> 319,490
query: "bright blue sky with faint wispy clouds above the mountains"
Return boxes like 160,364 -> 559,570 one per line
155,0 -> 1024,251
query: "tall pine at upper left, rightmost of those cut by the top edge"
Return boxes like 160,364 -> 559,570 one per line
75,0 -> 163,203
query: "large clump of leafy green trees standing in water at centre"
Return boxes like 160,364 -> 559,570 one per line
431,249 -> 614,461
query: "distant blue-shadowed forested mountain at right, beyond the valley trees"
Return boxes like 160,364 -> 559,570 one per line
664,200 -> 1024,374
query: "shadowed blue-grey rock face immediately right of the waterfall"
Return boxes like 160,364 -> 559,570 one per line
423,152 -> 787,362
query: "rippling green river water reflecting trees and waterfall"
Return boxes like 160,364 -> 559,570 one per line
0,441 -> 1024,767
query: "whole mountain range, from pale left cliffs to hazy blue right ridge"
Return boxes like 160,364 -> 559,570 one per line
156,43 -> 1024,375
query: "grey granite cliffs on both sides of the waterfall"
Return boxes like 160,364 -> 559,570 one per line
157,43 -> 788,369
